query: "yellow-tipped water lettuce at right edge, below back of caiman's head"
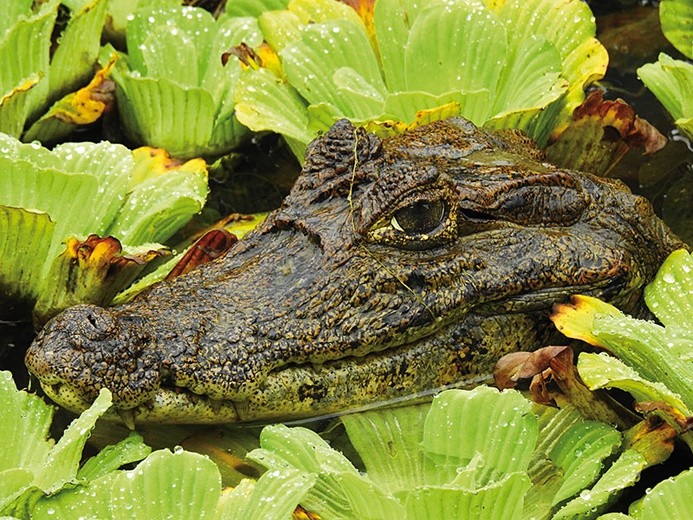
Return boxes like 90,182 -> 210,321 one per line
552,249 -> 693,448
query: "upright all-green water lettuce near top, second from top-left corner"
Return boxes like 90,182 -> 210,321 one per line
107,6 -> 262,158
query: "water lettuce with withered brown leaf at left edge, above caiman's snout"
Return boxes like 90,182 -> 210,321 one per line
0,134 -> 207,323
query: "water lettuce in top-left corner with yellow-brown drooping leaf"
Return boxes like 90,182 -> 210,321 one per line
0,0 -> 108,141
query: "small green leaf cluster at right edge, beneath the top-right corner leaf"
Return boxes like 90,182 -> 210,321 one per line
637,53 -> 693,139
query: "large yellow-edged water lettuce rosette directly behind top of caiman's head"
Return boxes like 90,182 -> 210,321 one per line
232,0 -> 607,158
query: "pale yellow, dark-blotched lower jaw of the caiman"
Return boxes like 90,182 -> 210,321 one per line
35,278 -> 628,428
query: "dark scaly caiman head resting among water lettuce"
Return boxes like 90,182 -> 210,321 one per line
26,119 -> 682,424
